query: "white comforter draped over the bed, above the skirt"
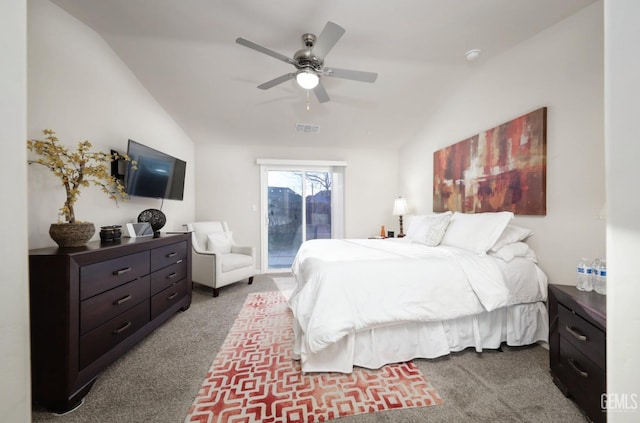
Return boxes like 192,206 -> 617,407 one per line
289,239 -> 546,354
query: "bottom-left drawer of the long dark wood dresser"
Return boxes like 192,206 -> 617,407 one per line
80,300 -> 149,369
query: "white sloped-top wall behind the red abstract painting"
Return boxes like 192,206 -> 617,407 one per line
400,2 -> 605,285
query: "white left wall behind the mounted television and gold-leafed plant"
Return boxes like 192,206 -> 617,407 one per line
27,1 -> 195,248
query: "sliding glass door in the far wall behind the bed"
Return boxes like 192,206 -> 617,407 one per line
262,161 -> 343,272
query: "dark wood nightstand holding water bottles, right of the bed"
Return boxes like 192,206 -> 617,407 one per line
549,285 -> 607,422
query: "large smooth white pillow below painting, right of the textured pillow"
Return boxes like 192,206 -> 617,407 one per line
441,211 -> 513,255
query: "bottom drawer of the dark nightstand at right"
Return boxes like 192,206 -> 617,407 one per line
554,337 -> 606,422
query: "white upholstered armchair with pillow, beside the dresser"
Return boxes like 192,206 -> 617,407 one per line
186,222 -> 256,297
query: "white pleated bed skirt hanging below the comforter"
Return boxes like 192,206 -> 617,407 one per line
294,302 -> 549,373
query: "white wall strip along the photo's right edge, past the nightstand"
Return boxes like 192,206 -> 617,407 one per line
605,0 -> 640,423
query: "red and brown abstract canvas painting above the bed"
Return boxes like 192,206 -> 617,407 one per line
433,107 -> 547,215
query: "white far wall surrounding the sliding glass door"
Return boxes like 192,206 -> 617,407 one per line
196,142 -> 401,267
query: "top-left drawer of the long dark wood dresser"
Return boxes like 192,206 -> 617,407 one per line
80,251 -> 150,300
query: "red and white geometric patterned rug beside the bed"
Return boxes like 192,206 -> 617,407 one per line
185,292 -> 442,423
